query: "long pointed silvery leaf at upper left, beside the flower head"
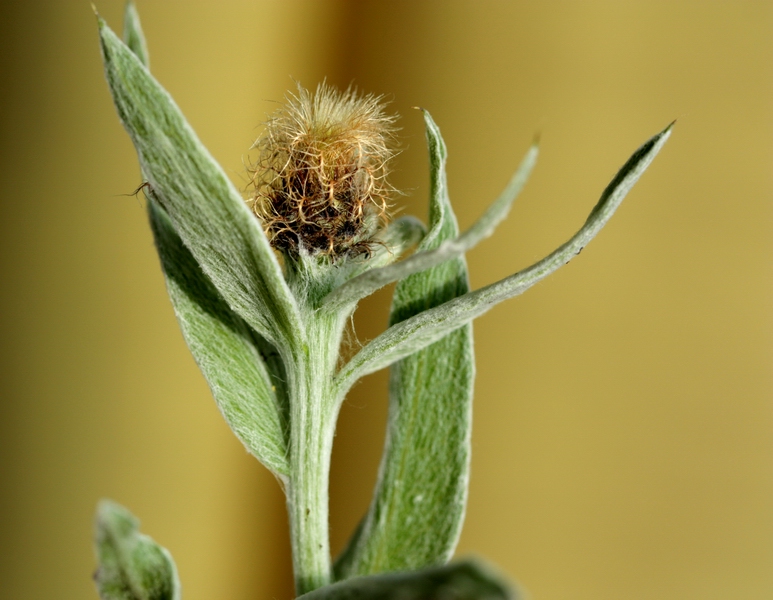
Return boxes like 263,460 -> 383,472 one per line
99,18 -> 302,350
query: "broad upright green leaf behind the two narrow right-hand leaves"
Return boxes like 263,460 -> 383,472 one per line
336,112 -> 474,578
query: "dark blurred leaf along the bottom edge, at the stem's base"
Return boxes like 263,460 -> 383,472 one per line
298,561 -> 516,600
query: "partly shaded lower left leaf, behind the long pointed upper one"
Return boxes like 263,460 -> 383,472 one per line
148,199 -> 288,475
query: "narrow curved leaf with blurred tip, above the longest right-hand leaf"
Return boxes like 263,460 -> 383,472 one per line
323,136 -> 539,310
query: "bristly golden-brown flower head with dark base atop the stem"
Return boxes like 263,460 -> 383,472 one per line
251,84 -> 395,259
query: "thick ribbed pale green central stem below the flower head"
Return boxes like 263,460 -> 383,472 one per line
286,311 -> 343,596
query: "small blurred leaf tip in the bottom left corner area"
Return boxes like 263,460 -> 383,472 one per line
94,500 -> 180,600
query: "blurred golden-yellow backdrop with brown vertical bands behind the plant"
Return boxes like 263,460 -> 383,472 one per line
0,0 -> 773,600
